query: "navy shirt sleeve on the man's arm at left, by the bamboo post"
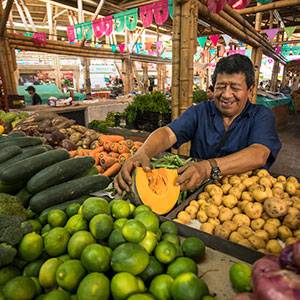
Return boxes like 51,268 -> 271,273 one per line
168,105 -> 199,149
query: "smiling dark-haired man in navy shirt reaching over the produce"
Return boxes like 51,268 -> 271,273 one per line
115,54 -> 281,193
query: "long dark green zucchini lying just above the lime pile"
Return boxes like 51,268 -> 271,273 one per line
29,175 -> 110,213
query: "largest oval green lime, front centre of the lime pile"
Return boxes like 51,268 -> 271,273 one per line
111,243 -> 149,275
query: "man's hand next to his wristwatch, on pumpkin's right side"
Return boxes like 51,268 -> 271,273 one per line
176,160 -> 211,191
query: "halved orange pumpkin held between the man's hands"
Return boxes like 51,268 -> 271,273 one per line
134,167 -> 180,215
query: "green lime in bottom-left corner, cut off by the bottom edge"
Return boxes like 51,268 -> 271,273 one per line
2,276 -> 36,300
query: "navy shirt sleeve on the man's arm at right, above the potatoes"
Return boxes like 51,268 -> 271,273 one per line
249,107 -> 281,168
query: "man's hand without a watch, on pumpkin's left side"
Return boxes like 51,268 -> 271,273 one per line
114,149 -> 151,195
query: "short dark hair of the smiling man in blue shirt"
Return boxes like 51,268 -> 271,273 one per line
212,54 -> 255,88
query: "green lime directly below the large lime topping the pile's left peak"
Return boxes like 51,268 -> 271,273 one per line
89,214 -> 114,240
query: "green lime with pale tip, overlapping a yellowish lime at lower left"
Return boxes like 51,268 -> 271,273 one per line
56,259 -> 85,291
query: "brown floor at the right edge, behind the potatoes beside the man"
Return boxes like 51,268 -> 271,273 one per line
271,112 -> 300,178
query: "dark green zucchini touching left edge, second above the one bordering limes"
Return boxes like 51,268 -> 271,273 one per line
0,149 -> 69,183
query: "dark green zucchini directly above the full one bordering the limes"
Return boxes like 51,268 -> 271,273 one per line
27,156 -> 95,194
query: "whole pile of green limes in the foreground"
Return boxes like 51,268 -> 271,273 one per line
0,197 -> 213,300
